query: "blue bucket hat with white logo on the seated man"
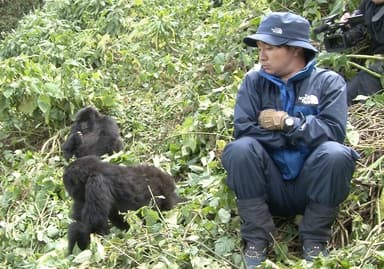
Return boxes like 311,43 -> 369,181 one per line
244,12 -> 317,52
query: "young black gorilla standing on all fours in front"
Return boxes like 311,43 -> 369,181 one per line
63,156 -> 181,254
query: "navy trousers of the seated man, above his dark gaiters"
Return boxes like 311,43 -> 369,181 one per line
222,137 -> 359,216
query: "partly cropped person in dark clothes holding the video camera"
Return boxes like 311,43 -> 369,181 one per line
342,0 -> 384,105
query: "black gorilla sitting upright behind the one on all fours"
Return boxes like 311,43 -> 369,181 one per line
62,107 -> 123,160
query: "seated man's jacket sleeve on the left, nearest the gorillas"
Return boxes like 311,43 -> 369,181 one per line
234,71 -> 286,149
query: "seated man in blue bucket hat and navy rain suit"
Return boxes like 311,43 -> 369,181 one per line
222,12 -> 359,268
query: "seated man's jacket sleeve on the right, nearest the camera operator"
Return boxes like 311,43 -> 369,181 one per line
286,70 -> 348,148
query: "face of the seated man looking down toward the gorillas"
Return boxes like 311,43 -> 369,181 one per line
257,41 -> 304,80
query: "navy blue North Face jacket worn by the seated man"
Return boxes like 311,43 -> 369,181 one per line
234,60 -> 347,180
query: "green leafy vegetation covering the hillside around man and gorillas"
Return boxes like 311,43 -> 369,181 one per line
0,0 -> 384,269
